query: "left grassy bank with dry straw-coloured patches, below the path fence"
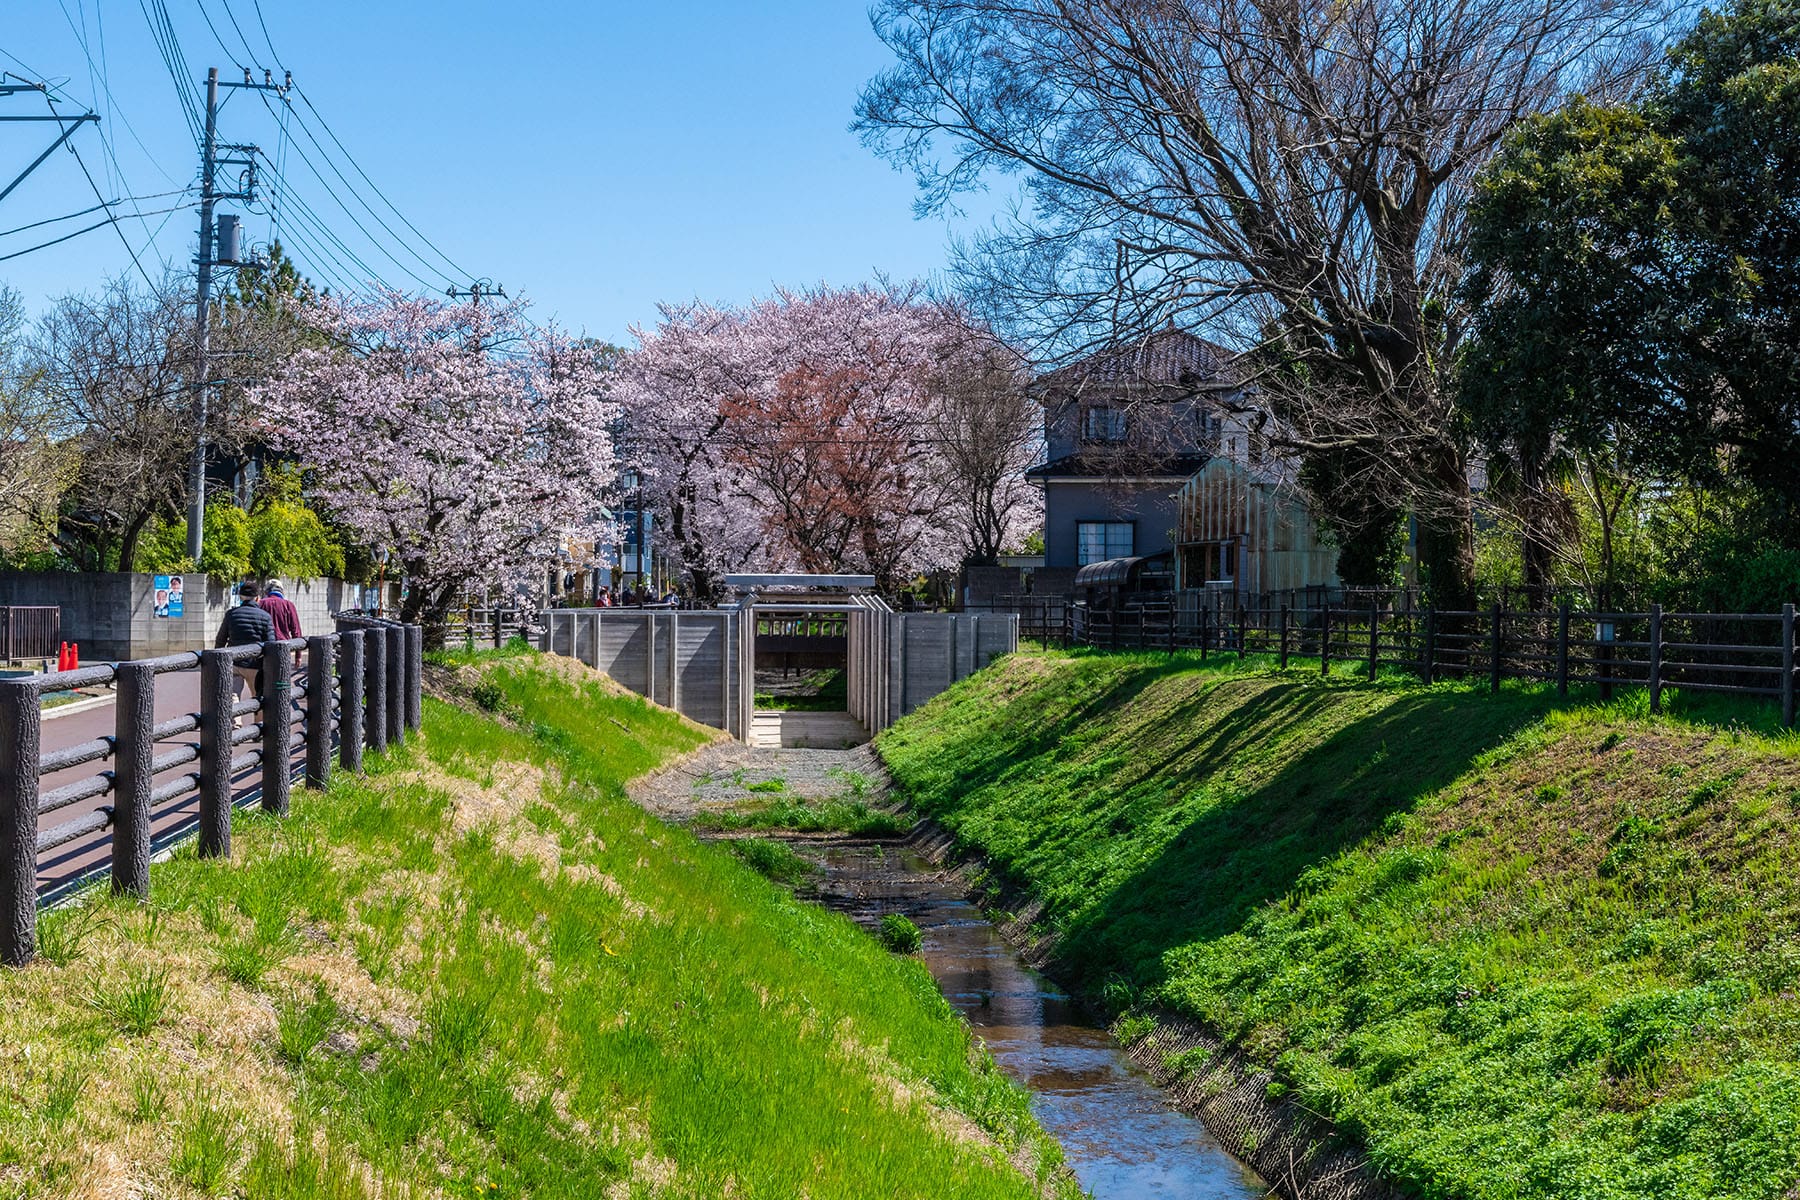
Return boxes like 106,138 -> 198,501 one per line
0,657 -> 1057,1200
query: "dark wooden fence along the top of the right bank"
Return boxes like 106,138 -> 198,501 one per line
1062,597 -> 1796,729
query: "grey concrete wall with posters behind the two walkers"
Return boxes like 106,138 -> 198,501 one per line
0,570 -> 360,662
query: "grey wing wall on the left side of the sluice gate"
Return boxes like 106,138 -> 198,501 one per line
540,608 -> 749,738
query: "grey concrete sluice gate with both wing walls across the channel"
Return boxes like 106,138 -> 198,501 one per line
540,576 -> 1019,747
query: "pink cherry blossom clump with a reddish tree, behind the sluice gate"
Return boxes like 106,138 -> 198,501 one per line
617,286 -> 1035,594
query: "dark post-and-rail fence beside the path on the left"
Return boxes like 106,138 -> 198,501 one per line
0,615 -> 425,966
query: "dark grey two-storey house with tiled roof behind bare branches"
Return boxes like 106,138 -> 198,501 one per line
1026,329 -> 1260,594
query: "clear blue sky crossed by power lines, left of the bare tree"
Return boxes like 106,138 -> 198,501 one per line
0,0 -> 986,340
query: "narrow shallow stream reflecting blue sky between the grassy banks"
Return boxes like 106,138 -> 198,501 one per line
812,846 -> 1267,1200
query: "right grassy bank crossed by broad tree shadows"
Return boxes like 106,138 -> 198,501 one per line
878,655 -> 1800,1200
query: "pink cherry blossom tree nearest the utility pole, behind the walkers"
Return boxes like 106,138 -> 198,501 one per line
252,293 -> 617,644
